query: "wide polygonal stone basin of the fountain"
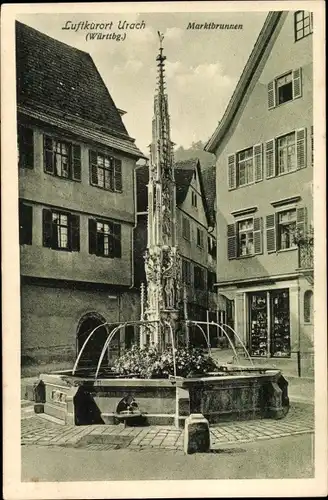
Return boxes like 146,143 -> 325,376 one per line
34,366 -> 289,426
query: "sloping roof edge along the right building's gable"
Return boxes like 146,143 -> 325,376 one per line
204,12 -> 283,153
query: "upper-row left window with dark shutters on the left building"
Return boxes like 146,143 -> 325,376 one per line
44,136 -> 81,181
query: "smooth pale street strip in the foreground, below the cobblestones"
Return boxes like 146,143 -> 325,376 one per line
22,434 -> 314,482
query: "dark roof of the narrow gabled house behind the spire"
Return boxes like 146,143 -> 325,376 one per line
136,158 -> 214,225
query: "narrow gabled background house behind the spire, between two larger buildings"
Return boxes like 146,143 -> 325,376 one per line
134,159 -> 218,344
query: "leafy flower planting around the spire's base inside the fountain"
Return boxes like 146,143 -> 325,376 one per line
113,346 -> 218,378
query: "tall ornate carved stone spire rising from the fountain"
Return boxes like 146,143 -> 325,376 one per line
141,32 -> 180,349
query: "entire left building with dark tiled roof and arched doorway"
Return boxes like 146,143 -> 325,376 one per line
16,23 -> 143,368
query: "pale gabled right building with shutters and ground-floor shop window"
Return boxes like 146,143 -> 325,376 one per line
206,11 -> 314,376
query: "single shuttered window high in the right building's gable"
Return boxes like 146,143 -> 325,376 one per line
268,68 -> 302,109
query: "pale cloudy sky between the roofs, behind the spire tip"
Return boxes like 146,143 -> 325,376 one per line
17,12 -> 267,154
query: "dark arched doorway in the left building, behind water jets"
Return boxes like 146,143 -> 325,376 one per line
77,312 -> 112,368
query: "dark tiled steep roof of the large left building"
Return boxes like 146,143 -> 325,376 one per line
16,21 -> 129,137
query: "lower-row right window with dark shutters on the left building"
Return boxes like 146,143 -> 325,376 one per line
89,219 -> 122,259
